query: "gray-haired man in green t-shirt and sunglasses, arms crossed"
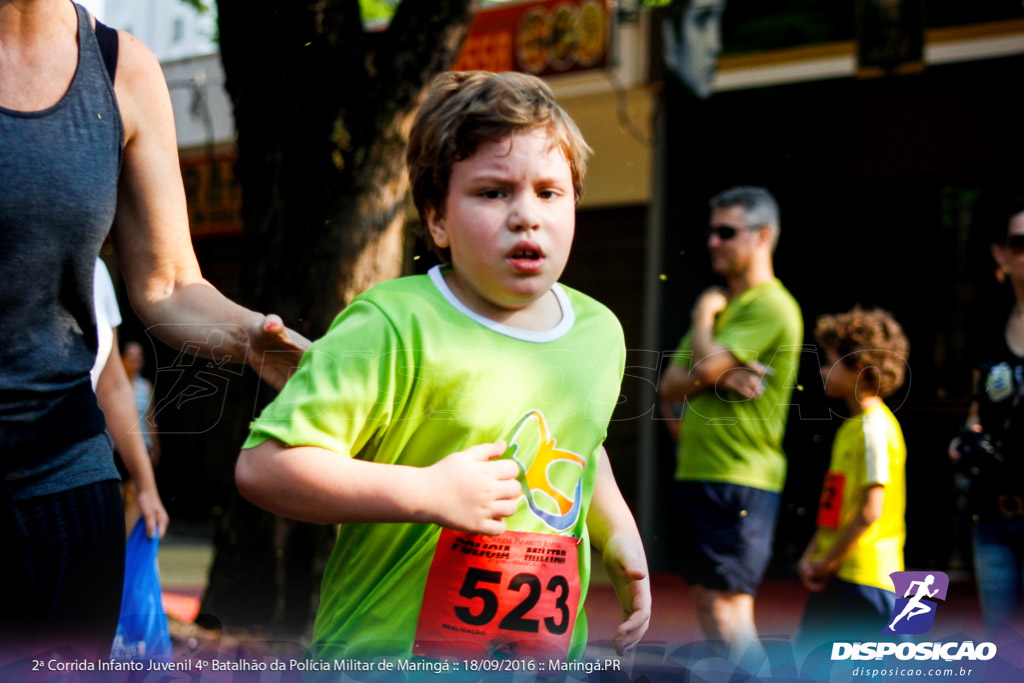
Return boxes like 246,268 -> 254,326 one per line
659,187 -> 804,654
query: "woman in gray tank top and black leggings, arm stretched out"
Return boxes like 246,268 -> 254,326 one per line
0,0 -> 308,665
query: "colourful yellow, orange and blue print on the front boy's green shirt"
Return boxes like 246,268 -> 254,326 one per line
504,411 -> 587,531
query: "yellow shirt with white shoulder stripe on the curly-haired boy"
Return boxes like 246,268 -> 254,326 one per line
817,403 -> 906,591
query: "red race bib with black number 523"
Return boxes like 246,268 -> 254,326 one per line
413,529 -> 580,659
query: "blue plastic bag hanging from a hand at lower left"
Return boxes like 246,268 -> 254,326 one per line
111,519 -> 173,661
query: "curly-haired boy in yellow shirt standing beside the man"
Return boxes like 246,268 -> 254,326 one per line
799,308 -> 909,649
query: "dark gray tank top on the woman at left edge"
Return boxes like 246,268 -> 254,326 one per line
0,4 -> 124,498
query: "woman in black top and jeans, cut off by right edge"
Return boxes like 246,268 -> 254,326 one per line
950,200 -> 1024,627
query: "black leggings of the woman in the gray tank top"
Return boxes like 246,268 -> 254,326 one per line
0,479 -> 125,659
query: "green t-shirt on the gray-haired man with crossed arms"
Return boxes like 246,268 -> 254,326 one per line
675,279 -> 804,493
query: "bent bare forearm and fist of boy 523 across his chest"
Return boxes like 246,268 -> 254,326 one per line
234,438 -> 522,536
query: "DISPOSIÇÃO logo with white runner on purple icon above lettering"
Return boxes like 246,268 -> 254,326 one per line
831,571 -> 996,661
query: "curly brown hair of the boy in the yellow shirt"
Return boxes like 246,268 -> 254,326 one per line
814,306 -> 910,398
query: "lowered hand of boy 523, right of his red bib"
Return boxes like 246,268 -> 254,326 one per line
602,538 -> 650,654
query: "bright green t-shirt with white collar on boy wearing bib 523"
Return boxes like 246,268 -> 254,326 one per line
245,268 -> 625,659
